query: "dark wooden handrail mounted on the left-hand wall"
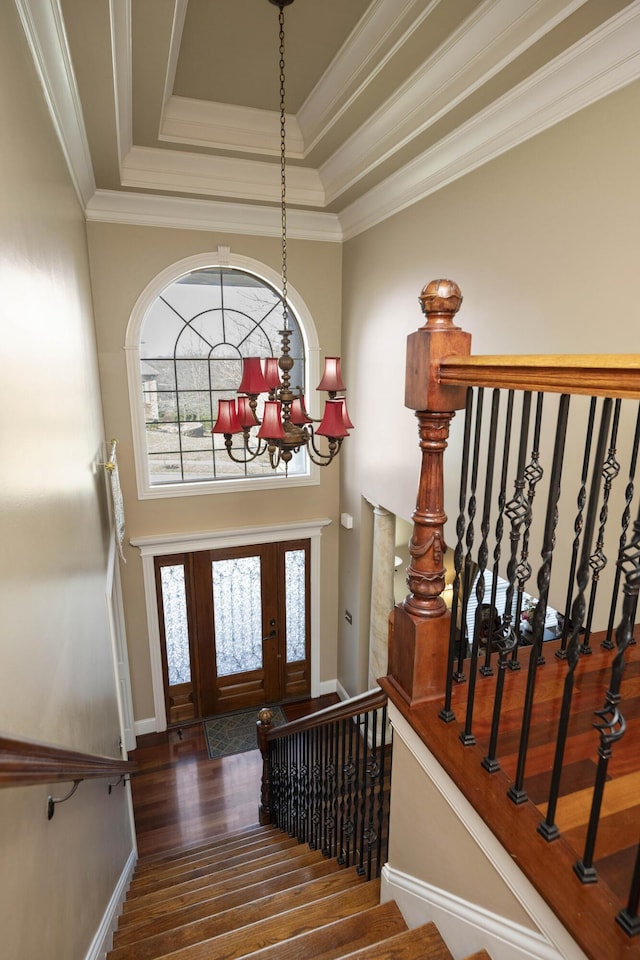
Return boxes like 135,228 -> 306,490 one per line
0,736 -> 137,787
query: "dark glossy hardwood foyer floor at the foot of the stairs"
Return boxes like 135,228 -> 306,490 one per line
129,694 -> 338,857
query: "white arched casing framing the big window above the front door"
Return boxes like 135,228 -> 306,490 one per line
125,247 -> 320,500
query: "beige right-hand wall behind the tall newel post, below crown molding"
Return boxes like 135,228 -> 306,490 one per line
340,83 -> 640,689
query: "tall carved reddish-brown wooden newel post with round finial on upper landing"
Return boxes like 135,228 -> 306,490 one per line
389,280 -> 471,703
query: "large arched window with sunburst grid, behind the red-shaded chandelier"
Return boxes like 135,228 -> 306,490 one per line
127,251 -> 317,497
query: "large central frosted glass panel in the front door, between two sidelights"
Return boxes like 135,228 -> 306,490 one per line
211,557 -> 262,677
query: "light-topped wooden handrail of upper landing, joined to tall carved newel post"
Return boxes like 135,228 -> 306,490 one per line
436,353 -> 640,399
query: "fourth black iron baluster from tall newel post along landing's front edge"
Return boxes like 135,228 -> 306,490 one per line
507,393 -> 571,803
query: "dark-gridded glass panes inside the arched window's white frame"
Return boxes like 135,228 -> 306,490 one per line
140,267 -> 309,488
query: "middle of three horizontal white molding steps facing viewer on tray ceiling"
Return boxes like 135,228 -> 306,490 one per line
121,146 -> 325,207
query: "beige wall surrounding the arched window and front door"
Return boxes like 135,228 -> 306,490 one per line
88,223 -> 349,720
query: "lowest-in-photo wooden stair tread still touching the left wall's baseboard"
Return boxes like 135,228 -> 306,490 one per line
108,868 -> 364,960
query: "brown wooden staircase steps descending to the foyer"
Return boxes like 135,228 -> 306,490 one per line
108,826 -> 490,960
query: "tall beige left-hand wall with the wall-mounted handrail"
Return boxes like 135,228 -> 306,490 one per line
0,3 -> 132,960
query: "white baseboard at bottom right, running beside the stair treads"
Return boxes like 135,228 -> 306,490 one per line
380,864 -> 584,960
